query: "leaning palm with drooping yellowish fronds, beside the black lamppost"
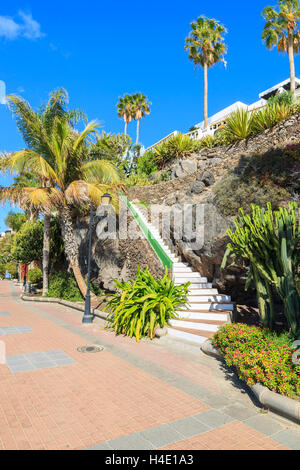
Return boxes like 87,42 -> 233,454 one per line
0,115 -> 119,295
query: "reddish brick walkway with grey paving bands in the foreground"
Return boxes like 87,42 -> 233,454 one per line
0,281 -> 300,450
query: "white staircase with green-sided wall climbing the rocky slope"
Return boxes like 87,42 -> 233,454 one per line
132,204 -> 233,344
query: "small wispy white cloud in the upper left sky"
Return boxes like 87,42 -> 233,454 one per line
0,11 -> 45,40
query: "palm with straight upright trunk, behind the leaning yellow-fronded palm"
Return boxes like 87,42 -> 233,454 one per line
4,88 -> 86,295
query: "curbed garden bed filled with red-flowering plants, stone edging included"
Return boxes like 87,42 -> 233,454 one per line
201,324 -> 300,422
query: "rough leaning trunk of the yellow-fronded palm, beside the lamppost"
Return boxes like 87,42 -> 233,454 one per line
59,206 -> 96,299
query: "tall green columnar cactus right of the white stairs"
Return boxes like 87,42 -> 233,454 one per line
222,203 -> 300,337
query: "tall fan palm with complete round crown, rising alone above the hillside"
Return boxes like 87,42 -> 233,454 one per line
184,16 -> 227,129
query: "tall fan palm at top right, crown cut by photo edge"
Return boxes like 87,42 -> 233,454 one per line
262,0 -> 300,95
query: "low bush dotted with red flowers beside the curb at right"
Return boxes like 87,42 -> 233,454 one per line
212,324 -> 300,398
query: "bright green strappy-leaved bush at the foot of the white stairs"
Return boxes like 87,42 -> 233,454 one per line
107,267 -> 189,341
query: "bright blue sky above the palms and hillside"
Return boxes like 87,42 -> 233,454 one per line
0,0 -> 300,231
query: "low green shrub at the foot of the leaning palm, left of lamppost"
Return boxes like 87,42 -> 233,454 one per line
47,272 -> 83,302
